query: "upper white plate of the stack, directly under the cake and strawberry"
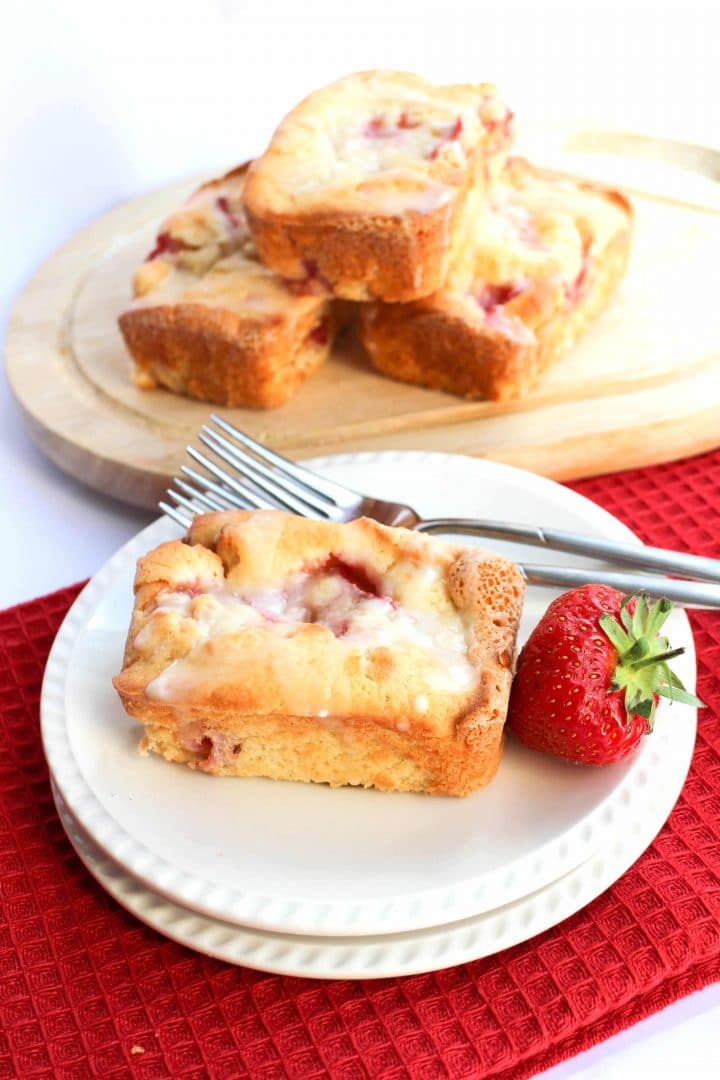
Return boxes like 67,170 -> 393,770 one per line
41,453 -> 695,937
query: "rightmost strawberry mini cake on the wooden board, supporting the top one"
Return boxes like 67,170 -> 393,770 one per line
361,158 -> 633,401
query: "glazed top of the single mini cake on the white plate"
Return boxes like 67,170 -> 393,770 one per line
117,511 -> 524,737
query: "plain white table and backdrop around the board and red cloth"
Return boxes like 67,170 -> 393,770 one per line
0,0 -> 720,1080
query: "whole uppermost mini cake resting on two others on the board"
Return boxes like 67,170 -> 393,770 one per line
244,71 -> 512,301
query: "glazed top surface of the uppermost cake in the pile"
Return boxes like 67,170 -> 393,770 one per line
247,70 -> 512,216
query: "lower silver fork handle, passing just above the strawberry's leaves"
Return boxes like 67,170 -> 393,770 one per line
518,563 -> 720,609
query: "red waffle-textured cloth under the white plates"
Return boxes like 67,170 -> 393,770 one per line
0,453 -> 720,1080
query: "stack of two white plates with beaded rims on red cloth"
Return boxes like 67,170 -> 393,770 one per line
42,453 -> 695,977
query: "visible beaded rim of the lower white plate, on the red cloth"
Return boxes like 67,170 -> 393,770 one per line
53,721 -> 692,978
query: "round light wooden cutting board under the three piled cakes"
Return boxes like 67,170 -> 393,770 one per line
6,130 -> 720,507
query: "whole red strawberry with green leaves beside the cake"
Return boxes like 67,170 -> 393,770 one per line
507,585 -> 702,765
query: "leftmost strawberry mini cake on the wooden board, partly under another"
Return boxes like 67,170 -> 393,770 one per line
119,165 -> 349,408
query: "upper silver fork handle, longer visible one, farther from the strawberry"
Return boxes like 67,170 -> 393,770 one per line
415,517 -> 720,598
